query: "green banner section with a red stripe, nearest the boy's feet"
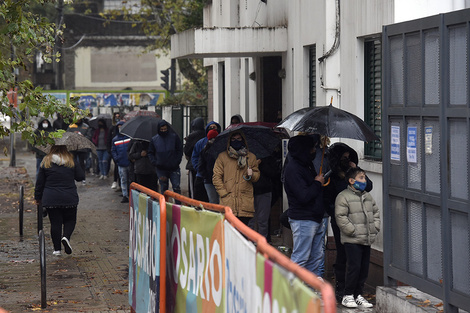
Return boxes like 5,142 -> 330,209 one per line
258,254 -> 320,313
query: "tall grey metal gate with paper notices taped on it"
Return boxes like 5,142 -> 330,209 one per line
382,10 -> 470,312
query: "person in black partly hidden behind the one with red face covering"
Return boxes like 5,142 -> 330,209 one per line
183,117 -> 206,199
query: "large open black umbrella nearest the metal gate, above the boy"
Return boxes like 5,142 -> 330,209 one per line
276,104 -> 380,141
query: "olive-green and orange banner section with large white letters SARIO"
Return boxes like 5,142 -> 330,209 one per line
166,203 -> 225,313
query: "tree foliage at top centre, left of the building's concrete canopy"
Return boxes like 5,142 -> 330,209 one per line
109,0 -> 207,104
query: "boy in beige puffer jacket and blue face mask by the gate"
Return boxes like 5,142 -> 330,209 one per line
335,167 -> 380,308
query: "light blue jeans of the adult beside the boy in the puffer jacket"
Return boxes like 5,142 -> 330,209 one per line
289,218 -> 325,277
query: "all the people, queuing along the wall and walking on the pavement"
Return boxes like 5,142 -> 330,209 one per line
35,114 -> 380,308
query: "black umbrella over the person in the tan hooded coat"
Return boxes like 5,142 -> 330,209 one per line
209,124 -> 281,159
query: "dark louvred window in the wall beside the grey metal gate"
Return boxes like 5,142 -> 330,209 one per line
364,39 -> 382,160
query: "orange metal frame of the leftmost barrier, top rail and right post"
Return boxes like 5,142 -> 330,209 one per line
129,183 -> 166,313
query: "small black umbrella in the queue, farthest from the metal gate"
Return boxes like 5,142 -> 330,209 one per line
120,116 -> 161,141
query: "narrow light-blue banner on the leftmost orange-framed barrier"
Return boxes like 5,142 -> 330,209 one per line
129,190 -> 161,313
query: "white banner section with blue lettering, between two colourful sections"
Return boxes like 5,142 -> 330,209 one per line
224,221 -> 263,313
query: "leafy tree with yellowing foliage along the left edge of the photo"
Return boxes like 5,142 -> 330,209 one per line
0,0 -> 86,151
